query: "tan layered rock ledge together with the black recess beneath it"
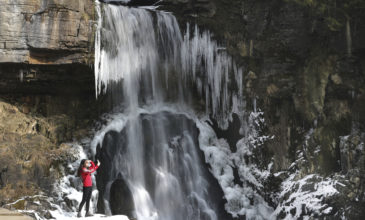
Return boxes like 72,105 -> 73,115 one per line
0,0 -> 96,94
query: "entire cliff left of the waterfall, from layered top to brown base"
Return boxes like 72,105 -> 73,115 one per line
0,0 -> 98,213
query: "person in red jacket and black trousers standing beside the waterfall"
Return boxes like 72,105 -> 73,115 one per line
77,159 -> 100,217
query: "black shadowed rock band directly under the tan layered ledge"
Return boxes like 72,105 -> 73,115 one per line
0,62 -> 95,95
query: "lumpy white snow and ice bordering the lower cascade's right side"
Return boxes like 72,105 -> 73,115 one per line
197,110 -> 274,219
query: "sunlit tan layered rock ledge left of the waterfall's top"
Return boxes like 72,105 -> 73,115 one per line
0,0 -> 95,64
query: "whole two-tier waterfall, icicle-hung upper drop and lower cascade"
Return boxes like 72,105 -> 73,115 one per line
92,2 -> 249,220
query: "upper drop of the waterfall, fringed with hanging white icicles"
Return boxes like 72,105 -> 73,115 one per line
95,5 -> 244,127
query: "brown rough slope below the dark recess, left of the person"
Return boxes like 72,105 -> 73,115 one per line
0,101 -> 74,206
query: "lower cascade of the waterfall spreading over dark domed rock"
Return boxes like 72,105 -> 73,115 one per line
93,109 -> 228,220
